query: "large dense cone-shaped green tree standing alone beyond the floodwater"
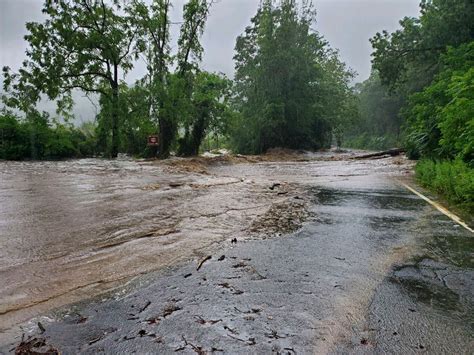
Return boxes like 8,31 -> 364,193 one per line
231,0 -> 351,153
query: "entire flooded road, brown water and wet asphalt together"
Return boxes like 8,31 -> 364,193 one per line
0,155 -> 474,353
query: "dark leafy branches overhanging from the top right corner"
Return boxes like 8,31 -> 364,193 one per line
371,0 -> 474,93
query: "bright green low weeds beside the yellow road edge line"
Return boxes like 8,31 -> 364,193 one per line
416,159 -> 474,212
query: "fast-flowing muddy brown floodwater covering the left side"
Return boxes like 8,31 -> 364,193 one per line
0,153 -> 407,340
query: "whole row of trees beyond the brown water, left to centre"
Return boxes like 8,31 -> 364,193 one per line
0,0 -> 357,159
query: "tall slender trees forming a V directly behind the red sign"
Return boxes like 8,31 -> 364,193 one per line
131,0 -> 214,158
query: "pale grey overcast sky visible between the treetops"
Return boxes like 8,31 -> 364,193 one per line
0,0 -> 419,119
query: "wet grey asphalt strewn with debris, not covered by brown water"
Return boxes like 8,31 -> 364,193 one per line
2,160 -> 474,354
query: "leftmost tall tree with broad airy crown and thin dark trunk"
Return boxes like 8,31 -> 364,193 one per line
3,0 -> 142,157
